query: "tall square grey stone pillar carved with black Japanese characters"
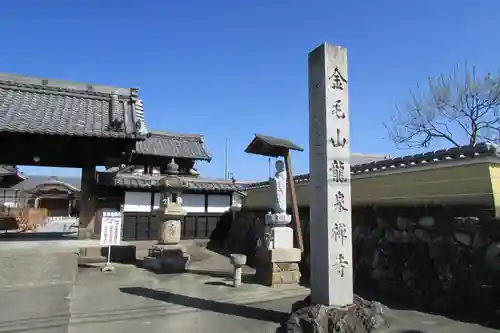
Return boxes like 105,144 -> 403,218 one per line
309,43 -> 353,306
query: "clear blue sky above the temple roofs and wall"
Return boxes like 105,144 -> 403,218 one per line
0,0 -> 500,179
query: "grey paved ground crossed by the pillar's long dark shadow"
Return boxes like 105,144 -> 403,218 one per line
69,265 -> 498,333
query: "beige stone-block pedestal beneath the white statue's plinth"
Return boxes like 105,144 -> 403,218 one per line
255,247 -> 301,287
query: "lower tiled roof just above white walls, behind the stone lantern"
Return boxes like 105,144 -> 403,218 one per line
98,172 -> 244,192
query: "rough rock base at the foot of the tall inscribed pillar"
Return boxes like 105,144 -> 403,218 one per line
277,296 -> 389,333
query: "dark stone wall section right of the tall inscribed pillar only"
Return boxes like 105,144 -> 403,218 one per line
353,210 -> 500,310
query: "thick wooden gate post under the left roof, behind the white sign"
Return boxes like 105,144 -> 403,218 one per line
78,165 -> 97,238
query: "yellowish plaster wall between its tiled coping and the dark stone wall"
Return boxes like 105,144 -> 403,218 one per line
244,161 -> 494,209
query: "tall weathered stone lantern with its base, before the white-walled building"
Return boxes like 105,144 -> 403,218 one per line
144,159 -> 190,273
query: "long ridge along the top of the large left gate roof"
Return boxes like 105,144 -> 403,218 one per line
0,73 -> 139,97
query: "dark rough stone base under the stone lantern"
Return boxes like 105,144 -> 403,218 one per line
143,245 -> 191,273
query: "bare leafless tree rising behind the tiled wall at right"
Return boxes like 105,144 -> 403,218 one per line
384,65 -> 500,148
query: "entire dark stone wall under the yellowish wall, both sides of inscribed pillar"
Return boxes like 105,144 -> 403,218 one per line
221,207 -> 500,310
